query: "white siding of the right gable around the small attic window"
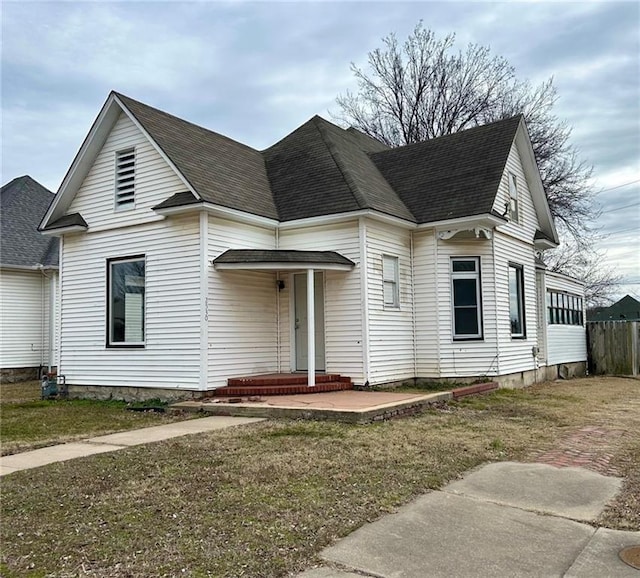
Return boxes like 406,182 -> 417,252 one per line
493,142 -> 540,242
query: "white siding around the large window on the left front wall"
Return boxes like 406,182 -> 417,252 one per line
60,215 -> 200,389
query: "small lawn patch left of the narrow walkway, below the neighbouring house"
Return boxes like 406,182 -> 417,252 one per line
0,381 -> 185,455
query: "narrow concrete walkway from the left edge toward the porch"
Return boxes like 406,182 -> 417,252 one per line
0,416 -> 263,476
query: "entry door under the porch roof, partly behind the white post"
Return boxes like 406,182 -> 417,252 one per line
293,273 -> 325,371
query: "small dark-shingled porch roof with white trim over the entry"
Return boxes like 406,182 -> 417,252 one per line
213,249 -> 355,271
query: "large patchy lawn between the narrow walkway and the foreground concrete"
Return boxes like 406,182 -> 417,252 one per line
0,378 -> 640,577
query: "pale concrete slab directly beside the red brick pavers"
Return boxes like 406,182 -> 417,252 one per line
443,462 -> 622,522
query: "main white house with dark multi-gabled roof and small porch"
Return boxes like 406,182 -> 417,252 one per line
41,93 -> 586,397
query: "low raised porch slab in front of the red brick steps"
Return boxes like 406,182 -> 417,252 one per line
171,390 -> 451,423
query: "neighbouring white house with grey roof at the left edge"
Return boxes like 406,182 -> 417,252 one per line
0,176 -> 58,382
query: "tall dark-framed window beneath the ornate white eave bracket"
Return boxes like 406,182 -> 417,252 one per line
451,257 -> 482,339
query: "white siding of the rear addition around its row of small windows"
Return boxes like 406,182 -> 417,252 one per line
544,273 -> 587,365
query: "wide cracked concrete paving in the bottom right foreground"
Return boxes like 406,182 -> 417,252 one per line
299,462 -> 640,578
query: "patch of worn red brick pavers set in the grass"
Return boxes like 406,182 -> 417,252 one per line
534,426 -> 624,476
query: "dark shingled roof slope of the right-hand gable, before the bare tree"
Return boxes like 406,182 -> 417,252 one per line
371,116 -> 522,223
